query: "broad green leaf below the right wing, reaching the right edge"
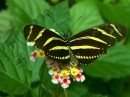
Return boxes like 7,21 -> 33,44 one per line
84,45 -> 130,78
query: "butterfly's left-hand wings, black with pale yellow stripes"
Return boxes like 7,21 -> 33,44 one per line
24,25 -> 70,65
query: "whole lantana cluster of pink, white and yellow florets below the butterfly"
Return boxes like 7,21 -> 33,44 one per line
30,50 -> 85,88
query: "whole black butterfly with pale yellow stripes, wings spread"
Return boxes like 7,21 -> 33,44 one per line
24,24 -> 126,65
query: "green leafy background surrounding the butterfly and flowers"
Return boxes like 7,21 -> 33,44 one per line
0,0 -> 130,97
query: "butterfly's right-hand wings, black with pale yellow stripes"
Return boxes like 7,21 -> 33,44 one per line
70,24 -> 126,64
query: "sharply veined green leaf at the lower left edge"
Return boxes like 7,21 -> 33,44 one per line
0,44 -> 30,94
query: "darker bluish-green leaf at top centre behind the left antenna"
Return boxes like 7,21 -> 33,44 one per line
35,0 -> 70,36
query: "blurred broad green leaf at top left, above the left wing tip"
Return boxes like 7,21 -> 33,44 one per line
7,0 -> 49,25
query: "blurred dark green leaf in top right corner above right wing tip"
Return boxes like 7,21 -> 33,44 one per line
99,3 -> 130,27
